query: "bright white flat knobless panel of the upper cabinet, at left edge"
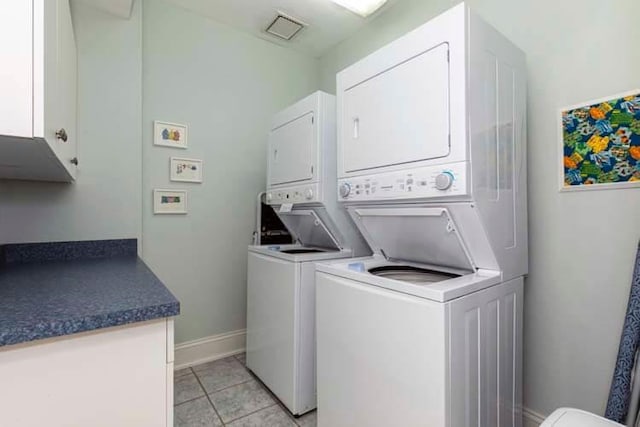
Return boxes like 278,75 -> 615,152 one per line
0,0 -> 33,138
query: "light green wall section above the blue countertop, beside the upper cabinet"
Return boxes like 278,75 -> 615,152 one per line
0,1 -> 142,243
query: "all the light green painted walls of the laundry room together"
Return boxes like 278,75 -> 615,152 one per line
0,0 -> 640,413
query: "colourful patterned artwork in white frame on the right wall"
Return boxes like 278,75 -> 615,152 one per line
559,89 -> 640,191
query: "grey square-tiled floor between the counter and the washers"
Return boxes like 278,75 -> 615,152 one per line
174,353 -> 316,427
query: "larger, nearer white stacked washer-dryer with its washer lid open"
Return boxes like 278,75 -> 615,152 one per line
316,4 -> 527,427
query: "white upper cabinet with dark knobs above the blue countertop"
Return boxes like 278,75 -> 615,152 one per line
0,0 -> 78,182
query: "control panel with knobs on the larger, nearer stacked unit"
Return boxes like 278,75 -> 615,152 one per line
338,162 -> 467,201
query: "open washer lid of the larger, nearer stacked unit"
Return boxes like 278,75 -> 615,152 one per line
349,207 -> 476,271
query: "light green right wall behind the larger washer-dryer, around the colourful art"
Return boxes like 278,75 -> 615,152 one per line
320,0 -> 640,420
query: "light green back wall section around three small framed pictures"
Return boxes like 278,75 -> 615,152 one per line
143,0 -> 318,343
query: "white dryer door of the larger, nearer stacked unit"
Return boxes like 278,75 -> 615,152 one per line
340,44 -> 449,172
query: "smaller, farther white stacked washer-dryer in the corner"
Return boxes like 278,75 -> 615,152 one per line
247,92 -> 371,415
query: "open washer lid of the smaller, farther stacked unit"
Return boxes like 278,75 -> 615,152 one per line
278,209 -> 341,250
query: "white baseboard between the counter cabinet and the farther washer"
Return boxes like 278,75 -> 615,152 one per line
174,329 -> 247,370
